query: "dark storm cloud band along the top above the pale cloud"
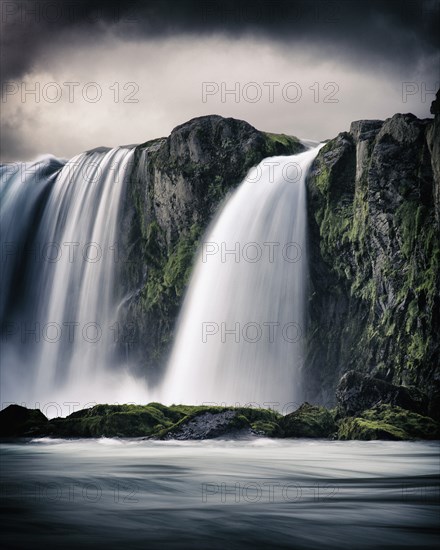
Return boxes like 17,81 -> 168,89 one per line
1,0 -> 440,85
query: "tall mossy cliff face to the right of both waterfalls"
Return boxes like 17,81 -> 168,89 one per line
304,114 -> 440,410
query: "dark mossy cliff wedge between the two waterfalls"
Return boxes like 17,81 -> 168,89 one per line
115,115 -> 304,381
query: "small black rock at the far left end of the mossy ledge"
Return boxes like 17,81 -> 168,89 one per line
0,405 -> 49,437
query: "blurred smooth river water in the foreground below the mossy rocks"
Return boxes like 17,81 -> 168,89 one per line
0,438 -> 439,550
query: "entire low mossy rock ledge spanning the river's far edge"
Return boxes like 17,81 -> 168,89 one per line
0,403 -> 440,440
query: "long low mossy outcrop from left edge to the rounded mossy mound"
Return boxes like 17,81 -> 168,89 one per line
0,403 -> 281,440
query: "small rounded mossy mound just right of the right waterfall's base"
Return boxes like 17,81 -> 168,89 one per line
280,403 -> 337,437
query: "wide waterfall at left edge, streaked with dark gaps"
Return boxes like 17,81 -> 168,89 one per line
0,148 -> 145,416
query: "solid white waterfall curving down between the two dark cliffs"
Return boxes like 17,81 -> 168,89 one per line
158,147 -> 320,409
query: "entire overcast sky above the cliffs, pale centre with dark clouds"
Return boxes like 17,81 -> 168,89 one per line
0,0 -> 440,161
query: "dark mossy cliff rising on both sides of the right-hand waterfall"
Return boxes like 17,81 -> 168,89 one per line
115,109 -> 440,410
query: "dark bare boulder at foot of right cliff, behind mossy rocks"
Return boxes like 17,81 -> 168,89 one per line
336,371 -> 428,416
